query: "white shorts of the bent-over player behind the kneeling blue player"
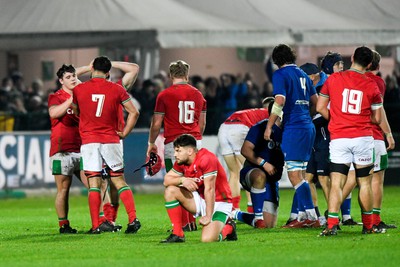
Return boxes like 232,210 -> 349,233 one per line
218,123 -> 249,156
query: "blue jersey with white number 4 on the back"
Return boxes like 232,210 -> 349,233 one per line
272,64 -> 317,128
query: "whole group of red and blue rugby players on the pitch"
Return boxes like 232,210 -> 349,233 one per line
48,44 -> 395,243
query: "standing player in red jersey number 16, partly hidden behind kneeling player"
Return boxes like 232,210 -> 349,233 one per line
147,60 -> 207,231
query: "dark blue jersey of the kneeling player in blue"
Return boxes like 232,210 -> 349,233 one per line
245,119 -> 284,168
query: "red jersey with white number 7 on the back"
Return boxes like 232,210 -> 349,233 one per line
74,78 -> 131,144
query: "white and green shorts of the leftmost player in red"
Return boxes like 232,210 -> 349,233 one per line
50,152 -> 81,176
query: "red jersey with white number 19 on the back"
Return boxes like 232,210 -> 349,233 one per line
320,70 -> 382,140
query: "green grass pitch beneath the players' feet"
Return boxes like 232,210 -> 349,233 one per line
0,187 -> 400,267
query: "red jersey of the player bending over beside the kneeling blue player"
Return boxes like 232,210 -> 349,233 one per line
224,108 -> 269,128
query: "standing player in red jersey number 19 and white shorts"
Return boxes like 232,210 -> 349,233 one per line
317,46 -> 382,236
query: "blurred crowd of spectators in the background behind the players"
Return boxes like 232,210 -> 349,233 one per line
0,68 -> 400,135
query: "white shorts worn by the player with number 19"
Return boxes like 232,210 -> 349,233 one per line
329,136 -> 374,165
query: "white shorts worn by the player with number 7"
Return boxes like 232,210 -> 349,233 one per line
81,143 -> 124,172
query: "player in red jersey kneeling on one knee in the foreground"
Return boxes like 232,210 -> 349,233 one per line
161,134 -> 237,243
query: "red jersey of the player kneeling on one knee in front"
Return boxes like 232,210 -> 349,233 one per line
173,148 -> 232,203
